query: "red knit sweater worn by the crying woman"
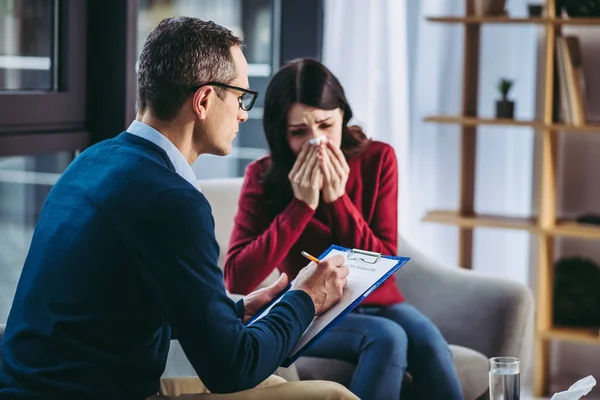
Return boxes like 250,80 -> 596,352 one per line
225,141 -> 404,305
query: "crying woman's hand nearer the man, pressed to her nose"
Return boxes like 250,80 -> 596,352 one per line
288,143 -> 323,210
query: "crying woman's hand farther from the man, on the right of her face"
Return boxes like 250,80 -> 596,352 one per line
320,141 -> 350,203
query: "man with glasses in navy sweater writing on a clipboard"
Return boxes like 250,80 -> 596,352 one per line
0,17 -> 356,400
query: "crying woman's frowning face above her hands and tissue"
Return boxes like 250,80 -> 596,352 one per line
286,103 -> 343,155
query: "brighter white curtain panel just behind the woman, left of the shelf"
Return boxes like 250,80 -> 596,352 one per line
323,0 -> 410,236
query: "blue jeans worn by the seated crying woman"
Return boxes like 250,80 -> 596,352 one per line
305,303 -> 463,400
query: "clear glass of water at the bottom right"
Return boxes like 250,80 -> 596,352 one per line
490,357 -> 521,400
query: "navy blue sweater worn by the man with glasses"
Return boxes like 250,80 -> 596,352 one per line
0,132 -> 314,400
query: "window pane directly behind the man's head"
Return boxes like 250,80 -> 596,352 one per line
137,0 -> 274,179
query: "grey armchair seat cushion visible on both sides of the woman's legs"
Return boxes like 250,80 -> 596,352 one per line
294,345 -> 488,400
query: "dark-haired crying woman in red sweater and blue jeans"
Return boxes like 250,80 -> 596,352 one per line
225,59 -> 462,400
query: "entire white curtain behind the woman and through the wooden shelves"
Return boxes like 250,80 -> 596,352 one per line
323,0 -> 537,283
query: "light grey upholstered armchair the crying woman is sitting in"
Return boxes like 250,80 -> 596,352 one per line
165,178 -> 533,400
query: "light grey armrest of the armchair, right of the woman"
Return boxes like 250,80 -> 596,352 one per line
396,238 -> 533,368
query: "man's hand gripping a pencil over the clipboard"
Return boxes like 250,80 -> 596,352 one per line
292,255 -> 350,315
